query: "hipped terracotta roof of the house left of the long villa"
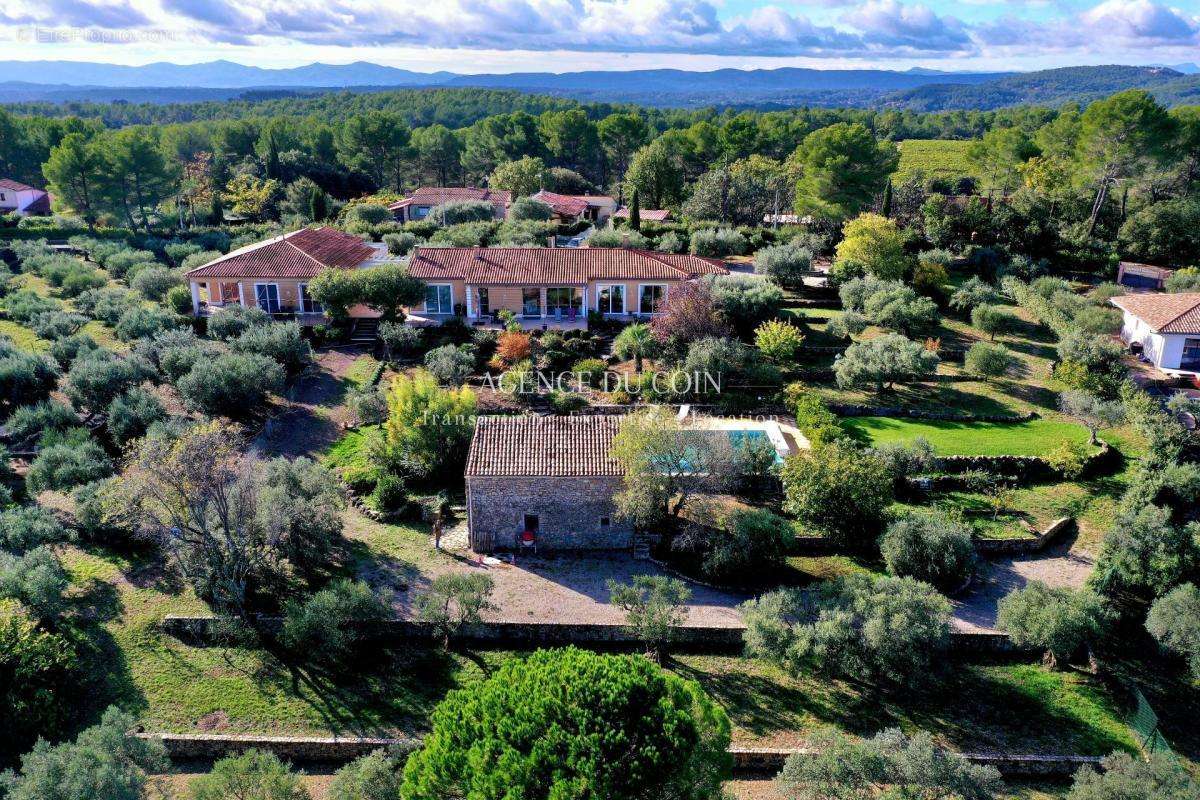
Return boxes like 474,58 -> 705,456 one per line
187,227 -> 376,278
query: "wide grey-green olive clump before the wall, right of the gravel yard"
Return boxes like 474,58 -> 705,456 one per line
742,575 -> 952,690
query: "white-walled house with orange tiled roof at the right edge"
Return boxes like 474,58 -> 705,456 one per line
1109,291 -> 1200,372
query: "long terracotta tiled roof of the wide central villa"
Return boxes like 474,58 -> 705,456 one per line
409,247 -> 728,285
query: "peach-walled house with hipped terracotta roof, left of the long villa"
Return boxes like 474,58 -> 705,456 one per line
186,227 -> 388,324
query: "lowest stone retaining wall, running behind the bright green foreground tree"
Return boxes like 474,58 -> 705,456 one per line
134,733 -> 1100,777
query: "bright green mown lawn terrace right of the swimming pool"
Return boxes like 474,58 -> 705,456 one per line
842,416 -> 1087,456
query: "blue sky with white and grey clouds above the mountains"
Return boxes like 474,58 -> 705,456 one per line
0,0 -> 1200,73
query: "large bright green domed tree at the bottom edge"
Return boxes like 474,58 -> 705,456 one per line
402,648 -> 730,800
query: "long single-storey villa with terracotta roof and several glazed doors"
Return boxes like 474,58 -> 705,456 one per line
409,247 -> 728,325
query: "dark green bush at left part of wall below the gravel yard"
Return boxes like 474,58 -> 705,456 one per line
280,581 -> 391,669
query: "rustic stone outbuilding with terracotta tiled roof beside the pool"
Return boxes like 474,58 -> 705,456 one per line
466,416 -> 634,553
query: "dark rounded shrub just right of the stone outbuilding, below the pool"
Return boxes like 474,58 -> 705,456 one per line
703,509 -> 793,582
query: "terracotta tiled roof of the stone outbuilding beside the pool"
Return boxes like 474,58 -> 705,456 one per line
467,415 -> 623,477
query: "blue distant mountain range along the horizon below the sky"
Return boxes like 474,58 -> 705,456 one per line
0,61 -> 1200,110
